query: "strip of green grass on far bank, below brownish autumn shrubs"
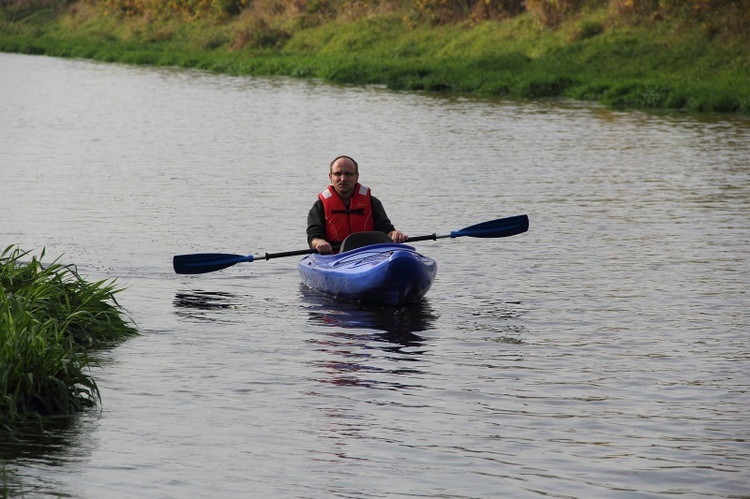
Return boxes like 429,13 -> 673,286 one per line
0,4 -> 750,114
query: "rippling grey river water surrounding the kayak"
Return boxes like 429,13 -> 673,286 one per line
0,54 -> 750,498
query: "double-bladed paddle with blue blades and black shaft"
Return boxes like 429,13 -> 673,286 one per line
172,215 -> 529,274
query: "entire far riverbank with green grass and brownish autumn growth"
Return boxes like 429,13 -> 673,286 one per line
0,0 -> 750,114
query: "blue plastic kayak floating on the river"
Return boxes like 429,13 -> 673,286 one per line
297,243 -> 437,306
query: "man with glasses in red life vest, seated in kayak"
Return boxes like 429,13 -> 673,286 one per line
307,156 -> 409,254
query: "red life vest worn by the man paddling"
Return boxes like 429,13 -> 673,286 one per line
318,183 -> 375,244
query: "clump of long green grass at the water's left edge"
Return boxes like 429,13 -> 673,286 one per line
0,246 -> 136,435
